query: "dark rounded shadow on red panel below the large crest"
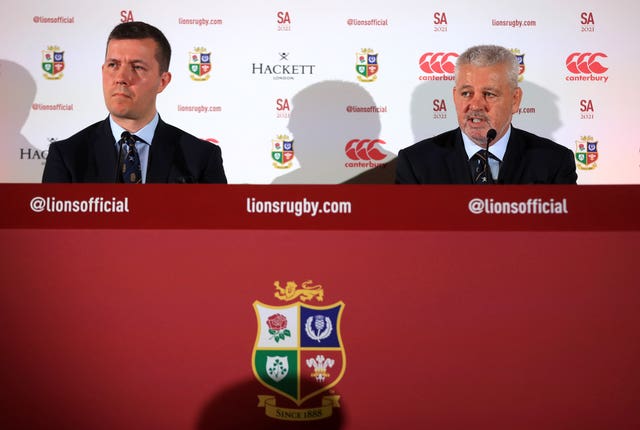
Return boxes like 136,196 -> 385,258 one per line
196,379 -> 344,430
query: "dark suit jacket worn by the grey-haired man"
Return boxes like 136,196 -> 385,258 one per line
396,127 -> 578,184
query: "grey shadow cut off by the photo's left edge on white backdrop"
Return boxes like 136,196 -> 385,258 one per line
0,59 -> 45,182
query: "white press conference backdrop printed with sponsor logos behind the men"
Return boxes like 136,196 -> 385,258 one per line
0,0 -> 640,184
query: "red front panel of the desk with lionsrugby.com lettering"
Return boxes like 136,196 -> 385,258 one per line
0,185 -> 640,430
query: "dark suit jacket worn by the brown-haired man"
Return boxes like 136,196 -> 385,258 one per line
42,118 -> 227,184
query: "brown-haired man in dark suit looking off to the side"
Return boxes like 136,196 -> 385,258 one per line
42,22 -> 227,183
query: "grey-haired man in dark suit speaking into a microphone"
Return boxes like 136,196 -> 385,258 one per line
396,45 -> 577,184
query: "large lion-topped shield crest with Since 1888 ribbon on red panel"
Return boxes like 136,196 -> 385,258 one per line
252,280 -> 346,421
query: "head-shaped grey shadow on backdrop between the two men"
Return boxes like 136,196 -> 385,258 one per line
272,81 -> 393,184
